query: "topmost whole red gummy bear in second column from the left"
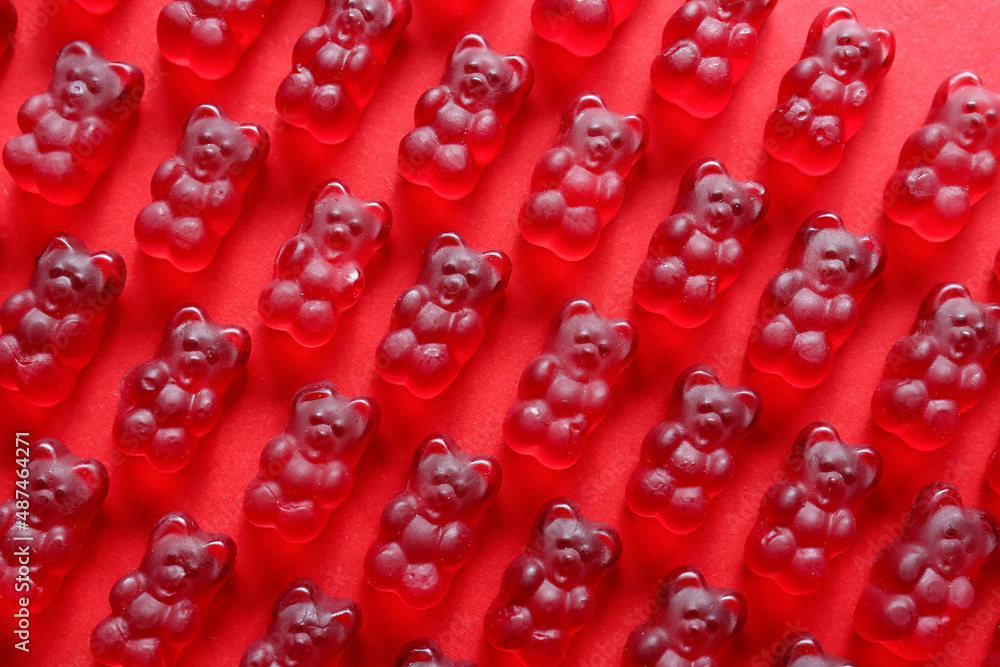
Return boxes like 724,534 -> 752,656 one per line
135,104 -> 270,272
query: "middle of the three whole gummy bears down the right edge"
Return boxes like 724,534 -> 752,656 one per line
872,283 -> 1000,451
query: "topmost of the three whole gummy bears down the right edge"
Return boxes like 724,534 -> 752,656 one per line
883,72 -> 1000,241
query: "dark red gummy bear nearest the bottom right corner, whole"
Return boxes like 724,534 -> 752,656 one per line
854,482 -> 1000,660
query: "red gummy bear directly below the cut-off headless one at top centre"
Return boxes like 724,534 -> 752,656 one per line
518,93 -> 649,261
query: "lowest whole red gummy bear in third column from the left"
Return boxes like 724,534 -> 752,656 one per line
243,380 -> 382,542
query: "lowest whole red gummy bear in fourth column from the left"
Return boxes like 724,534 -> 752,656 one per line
365,433 -> 501,609
